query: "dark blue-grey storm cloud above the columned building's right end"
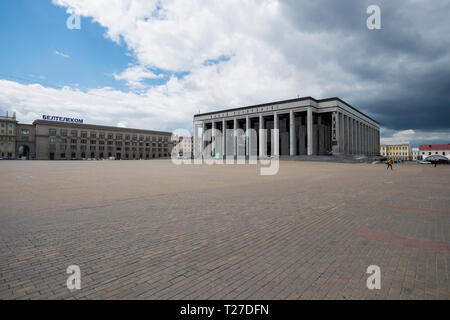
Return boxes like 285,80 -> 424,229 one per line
282,0 -> 450,139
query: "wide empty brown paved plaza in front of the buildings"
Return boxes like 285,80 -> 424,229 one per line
0,160 -> 450,299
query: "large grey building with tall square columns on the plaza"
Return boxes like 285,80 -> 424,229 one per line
194,97 -> 380,158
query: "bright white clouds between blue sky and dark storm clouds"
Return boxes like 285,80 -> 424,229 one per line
0,0 -> 446,137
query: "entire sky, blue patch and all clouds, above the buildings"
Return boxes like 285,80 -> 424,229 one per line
0,0 -> 450,145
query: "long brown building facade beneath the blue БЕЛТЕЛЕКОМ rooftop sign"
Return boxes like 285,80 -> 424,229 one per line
33,120 -> 172,160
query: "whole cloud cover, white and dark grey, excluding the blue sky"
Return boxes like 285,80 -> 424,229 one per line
0,0 -> 450,140
